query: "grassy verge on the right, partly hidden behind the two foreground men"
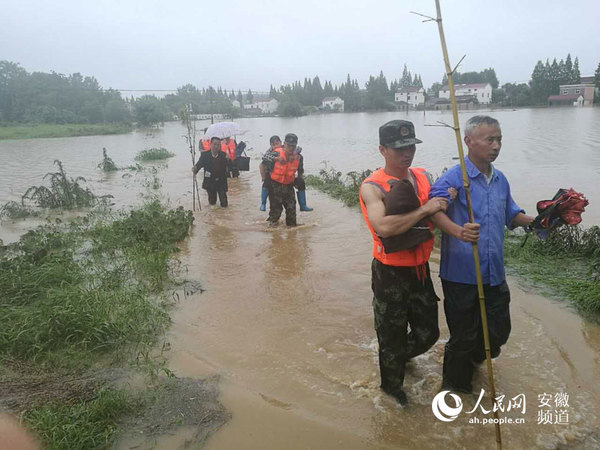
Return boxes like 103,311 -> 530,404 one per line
306,168 -> 600,320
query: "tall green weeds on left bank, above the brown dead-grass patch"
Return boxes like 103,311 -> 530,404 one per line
0,202 -> 193,367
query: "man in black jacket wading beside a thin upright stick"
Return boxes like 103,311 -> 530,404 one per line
192,137 -> 228,208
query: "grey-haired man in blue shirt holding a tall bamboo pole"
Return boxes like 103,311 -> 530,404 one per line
429,116 -> 533,393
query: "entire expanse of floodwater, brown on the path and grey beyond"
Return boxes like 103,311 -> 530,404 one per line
0,108 -> 600,449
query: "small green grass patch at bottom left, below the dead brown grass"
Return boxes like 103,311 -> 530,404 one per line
22,390 -> 142,450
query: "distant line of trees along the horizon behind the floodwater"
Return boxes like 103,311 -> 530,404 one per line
0,54 -> 600,125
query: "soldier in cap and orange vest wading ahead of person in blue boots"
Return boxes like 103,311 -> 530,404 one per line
262,133 -> 300,227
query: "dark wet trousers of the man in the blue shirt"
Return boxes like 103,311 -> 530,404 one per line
442,280 -> 511,392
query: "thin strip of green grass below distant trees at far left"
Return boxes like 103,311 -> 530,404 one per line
0,123 -> 133,140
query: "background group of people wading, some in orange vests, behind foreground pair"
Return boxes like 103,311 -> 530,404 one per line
192,133 -> 313,226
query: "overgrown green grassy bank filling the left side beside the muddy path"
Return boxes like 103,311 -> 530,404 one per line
0,161 -> 193,449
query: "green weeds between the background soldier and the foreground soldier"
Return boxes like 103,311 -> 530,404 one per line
305,165 -> 371,206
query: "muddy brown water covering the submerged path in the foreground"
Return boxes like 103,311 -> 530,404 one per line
145,174 -> 600,449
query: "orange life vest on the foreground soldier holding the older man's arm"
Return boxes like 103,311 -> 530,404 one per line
358,168 -> 433,267
